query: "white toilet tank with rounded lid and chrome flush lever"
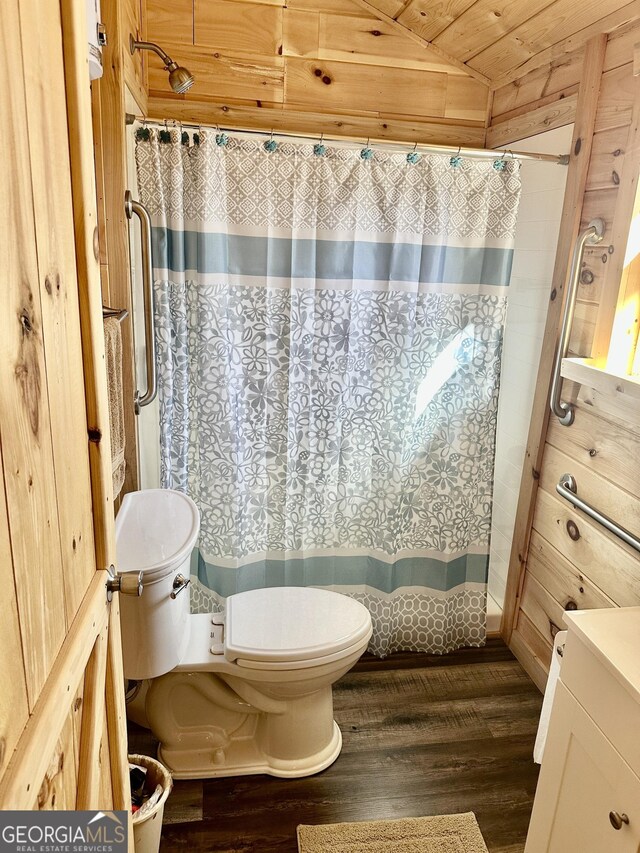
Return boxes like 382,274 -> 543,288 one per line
116,489 -> 200,680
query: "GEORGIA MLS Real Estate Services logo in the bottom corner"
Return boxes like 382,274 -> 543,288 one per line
0,811 -> 127,853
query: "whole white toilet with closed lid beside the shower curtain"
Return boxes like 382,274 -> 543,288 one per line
116,489 -> 372,779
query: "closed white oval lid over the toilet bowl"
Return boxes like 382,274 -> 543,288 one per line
224,587 -> 371,662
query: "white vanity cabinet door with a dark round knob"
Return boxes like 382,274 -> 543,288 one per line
525,682 -> 640,853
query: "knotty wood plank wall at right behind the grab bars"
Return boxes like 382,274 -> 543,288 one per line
488,23 -> 640,687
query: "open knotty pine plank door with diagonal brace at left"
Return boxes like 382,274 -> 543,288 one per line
0,0 -> 129,809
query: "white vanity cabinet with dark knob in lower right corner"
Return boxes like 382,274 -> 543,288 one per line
525,607 -> 640,853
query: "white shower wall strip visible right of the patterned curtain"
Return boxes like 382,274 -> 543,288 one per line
489,125 -> 573,607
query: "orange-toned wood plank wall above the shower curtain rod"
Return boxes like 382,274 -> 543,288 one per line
146,0 -> 488,145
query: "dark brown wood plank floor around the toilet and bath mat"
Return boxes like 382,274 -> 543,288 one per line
130,640 -> 542,853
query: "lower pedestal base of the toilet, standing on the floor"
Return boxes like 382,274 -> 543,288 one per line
144,662 -> 350,779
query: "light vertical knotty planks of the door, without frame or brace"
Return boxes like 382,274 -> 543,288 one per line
0,0 -> 95,808
